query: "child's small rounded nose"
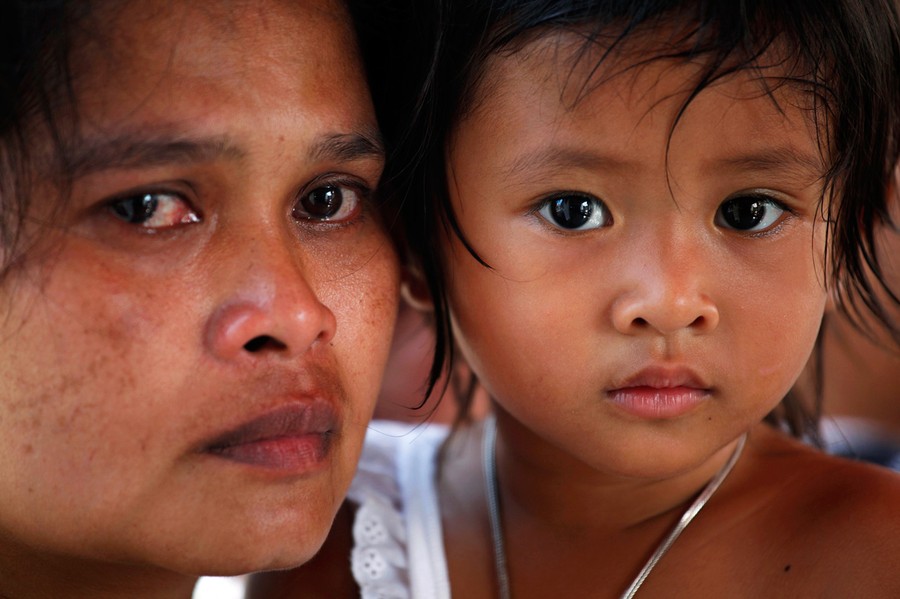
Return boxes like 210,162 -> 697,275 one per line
613,233 -> 719,335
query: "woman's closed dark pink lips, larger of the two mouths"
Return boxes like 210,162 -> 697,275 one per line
202,400 -> 337,472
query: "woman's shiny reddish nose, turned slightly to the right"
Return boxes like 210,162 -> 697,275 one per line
205,231 -> 337,361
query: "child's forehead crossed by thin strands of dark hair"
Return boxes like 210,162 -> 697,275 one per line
460,29 -> 828,162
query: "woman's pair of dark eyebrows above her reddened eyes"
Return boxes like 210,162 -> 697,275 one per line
59,125 -> 385,177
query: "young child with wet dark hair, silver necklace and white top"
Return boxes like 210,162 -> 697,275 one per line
256,0 -> 900,599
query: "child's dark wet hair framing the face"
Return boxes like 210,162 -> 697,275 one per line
402,0 -> 900,437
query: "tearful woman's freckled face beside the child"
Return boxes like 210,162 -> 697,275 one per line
0,0 -> 398,573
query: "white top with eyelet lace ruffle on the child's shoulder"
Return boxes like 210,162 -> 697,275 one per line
348,421 -> 450,599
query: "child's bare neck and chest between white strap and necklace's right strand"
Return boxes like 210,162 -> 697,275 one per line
439,410 -> 741,598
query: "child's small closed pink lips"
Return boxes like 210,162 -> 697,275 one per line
606,368 -> 712,420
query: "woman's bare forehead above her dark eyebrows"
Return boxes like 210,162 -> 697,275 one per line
44,0 -> 377,165
